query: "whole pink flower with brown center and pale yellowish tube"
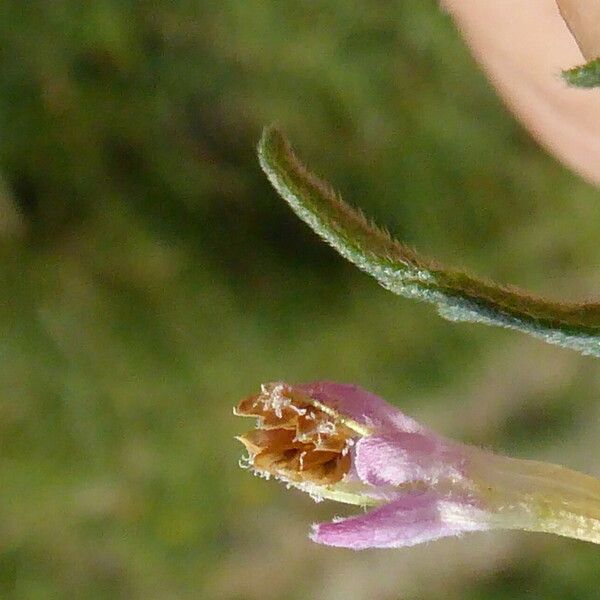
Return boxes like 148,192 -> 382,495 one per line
234,382 -> 600,550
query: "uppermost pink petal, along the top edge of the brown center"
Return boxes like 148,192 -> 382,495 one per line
294,381 -> 427,432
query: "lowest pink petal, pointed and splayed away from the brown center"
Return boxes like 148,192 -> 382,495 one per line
310,492 -> 488,550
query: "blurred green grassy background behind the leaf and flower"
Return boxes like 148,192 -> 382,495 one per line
0,0 -> 600,600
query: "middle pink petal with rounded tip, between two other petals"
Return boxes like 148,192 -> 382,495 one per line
354,432 -> 462,486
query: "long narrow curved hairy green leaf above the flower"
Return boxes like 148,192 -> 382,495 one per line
258,127 -> 600,357
